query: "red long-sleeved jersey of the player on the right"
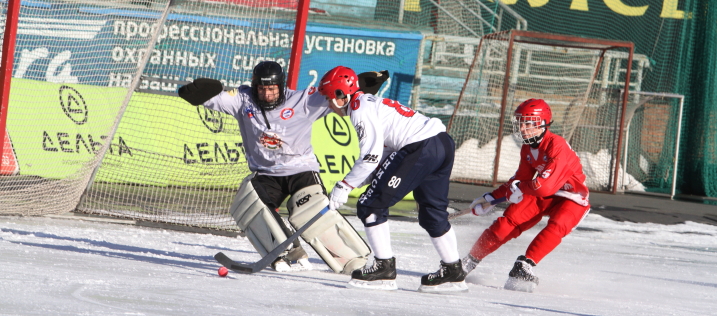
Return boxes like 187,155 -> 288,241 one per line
491,130 -> 590,206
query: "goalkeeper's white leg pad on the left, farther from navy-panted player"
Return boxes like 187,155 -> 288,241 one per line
229,174 -> 287,257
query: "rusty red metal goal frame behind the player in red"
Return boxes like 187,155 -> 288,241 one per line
447,30 -> 635,194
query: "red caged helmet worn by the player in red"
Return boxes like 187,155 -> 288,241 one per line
513,99 -> 553,144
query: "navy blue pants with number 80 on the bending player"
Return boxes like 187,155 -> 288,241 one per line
356,132 -> 456,238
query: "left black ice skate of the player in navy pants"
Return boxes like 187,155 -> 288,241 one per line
348,257 -> 398,290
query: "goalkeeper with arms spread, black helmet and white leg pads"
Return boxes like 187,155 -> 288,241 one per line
178,61 -> 370,273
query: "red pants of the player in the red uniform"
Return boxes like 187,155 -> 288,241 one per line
470,195 -> 590,263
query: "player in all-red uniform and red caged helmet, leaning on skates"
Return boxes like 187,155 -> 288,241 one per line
462,99 -> 590,292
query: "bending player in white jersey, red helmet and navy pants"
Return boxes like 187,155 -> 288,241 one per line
319,66 -> 468,292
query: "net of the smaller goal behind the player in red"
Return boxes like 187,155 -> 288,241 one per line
448,30 -> 633,191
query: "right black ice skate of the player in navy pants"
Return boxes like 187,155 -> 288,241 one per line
418,260 -> 468,293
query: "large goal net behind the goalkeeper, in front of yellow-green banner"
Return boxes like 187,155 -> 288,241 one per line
0,0 -> 297,229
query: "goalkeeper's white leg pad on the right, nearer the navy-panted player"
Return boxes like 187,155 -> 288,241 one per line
286,184 -> 371,274
